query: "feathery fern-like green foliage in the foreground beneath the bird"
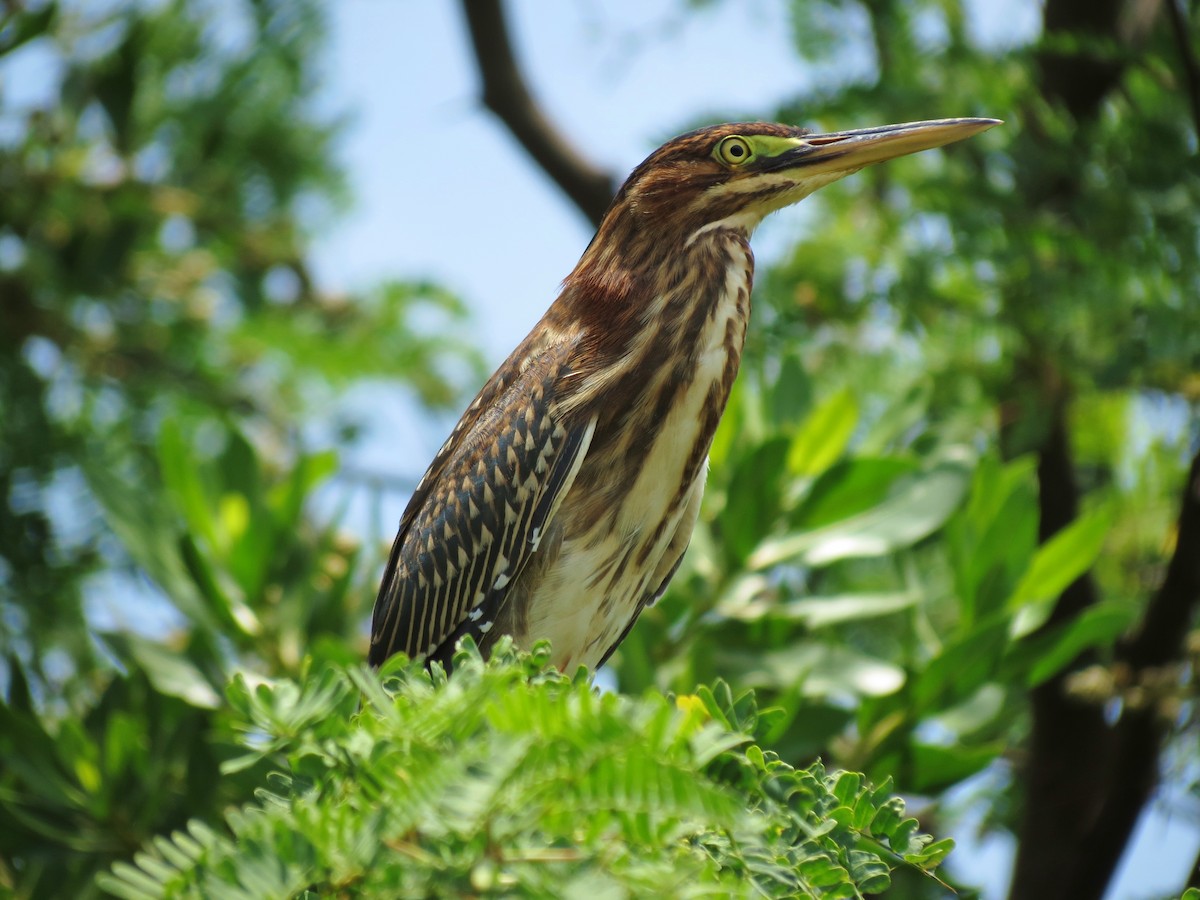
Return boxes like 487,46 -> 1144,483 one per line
101,644 -> 952,900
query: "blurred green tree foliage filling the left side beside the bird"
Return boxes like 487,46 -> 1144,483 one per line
0,0 -> 478,896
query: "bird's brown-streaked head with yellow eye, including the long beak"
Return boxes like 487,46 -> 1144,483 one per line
606,119 -> 1000,248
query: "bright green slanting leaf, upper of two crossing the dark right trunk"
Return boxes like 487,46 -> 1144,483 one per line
1006,506 -> 1112,637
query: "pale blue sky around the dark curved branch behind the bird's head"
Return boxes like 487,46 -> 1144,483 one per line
316,0 -> 805,360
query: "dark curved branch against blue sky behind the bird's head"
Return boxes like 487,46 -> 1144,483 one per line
462,0 -> 617,226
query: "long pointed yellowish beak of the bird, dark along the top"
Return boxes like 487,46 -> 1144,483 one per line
770,119 -> 1001,174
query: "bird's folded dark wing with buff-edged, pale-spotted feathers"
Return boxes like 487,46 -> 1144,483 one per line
370,346 -> 595,666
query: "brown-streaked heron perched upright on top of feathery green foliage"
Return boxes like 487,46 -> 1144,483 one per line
368,118 -> 1001,672
